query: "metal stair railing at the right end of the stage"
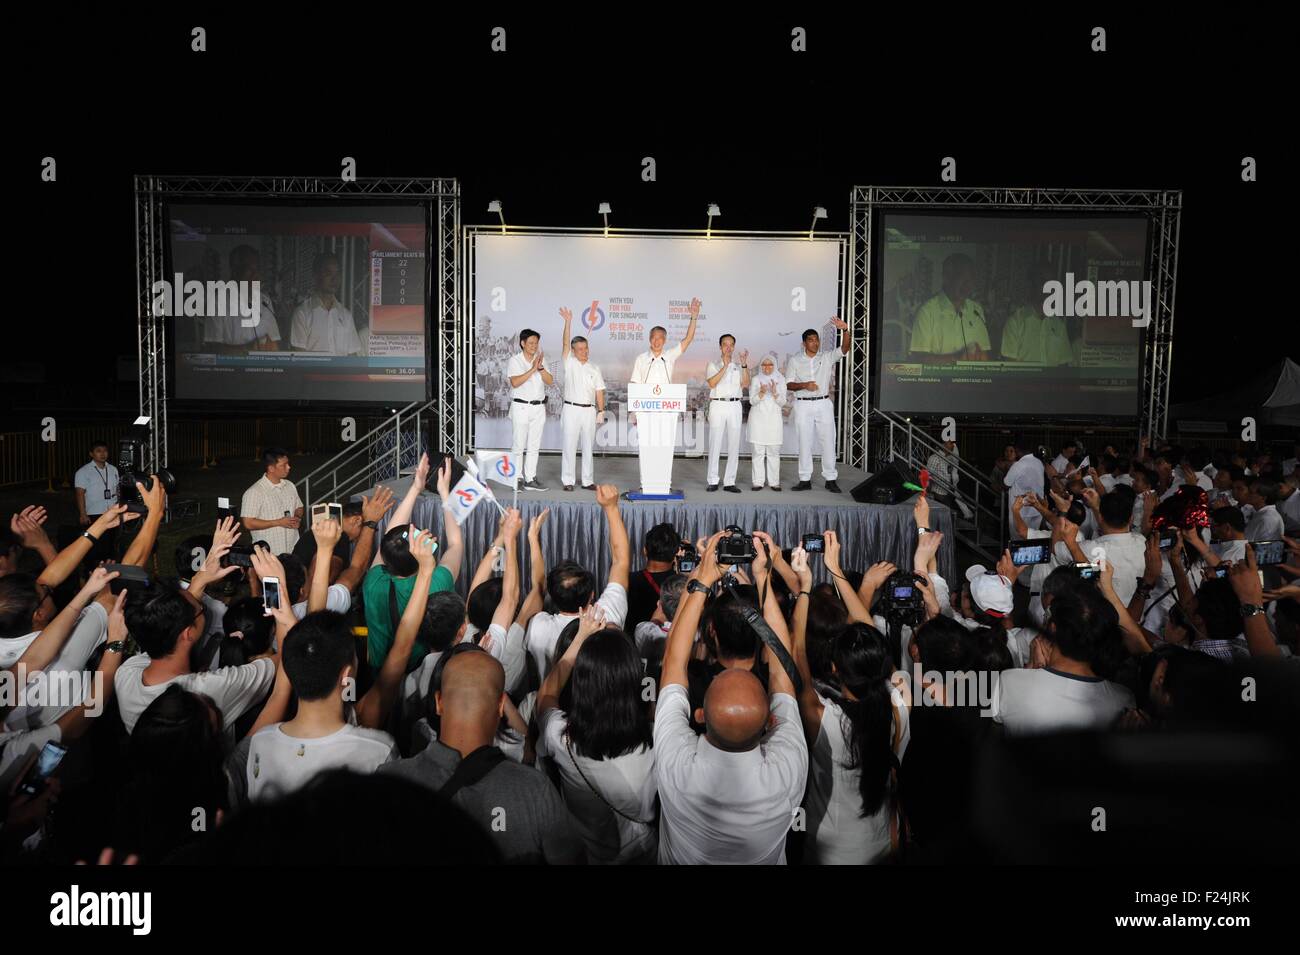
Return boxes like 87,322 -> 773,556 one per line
871,408 -> 1006,563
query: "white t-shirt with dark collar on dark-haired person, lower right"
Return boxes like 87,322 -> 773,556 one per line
992,668 -> 1134,734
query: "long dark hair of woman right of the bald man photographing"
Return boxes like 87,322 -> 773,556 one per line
831,624 -> 894,819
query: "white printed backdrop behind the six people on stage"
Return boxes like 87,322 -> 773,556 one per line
472,233 -> 848,453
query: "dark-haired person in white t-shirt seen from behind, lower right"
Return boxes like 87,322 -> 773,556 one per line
991,582 -> 1134,735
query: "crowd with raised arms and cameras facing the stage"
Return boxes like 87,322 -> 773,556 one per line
0,446 -> 1300,864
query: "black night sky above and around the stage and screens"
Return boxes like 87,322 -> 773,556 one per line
0,5 -> 1300,429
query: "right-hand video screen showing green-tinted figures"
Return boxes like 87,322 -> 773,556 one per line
874,213 -> 1153,417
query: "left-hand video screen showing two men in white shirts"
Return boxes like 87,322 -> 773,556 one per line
165,203 -> 428,401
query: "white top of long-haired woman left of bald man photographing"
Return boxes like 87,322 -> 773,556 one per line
537,709 -> 655,865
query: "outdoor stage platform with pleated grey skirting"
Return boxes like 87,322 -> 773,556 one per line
380,453 -> 957,590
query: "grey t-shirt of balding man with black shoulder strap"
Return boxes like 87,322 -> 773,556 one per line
377,739 -> 584,865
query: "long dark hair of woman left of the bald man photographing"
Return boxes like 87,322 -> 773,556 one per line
568,629 -> 653,759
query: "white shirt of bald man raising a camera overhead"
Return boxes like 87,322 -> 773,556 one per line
654,683 -> 809,865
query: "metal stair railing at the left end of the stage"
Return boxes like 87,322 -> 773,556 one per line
298,401 -> 436,509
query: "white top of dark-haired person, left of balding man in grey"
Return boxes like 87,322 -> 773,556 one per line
248,722 -> 400,803
